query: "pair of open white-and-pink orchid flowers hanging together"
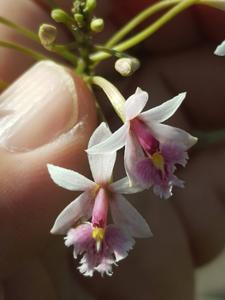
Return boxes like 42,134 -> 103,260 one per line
48,88 -> 197,276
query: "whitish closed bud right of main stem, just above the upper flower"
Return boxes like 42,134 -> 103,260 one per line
115,57 -> 140,77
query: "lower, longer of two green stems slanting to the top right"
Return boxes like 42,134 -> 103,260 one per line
90,0 -> 198,62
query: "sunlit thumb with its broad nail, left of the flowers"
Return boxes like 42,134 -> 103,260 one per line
0,61 -> 96,275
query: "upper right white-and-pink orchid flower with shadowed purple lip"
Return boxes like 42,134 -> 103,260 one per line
87,88 -> 197,198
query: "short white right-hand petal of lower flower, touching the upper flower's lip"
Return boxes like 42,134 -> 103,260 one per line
110,177 -> 144,194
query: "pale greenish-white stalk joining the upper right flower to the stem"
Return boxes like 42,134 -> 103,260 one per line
92,76 -> 125,122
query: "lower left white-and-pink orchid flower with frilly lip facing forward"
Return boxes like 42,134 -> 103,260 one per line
48,123 -> 151,276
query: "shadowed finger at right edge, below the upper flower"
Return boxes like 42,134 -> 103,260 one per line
173,147 -> 225,265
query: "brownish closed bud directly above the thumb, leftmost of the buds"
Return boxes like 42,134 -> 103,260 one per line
38,24 -> 57,48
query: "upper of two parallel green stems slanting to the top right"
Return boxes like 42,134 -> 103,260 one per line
105,0 -> 181,47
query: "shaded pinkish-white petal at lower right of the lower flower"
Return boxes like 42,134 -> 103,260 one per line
110,194 -> 152,237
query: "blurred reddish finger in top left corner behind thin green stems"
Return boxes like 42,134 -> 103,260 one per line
0,0 -> 49,82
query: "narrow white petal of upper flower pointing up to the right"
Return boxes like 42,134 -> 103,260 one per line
140,93 -> 186,124
